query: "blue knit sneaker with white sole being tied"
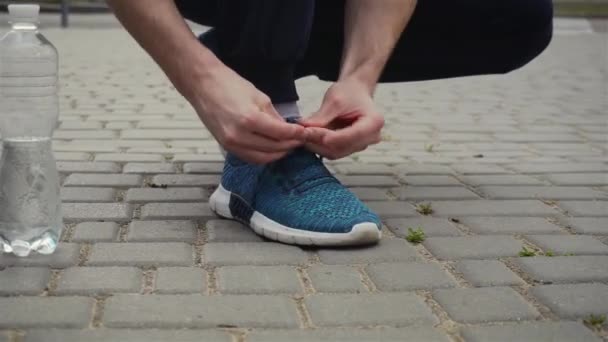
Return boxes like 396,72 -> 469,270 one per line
209,148 -> 382,246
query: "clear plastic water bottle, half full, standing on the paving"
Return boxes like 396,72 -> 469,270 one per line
0,5 -> 63,257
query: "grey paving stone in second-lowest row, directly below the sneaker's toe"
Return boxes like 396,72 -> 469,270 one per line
304,293 -> 438,327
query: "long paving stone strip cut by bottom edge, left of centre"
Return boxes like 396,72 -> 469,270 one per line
23,328 -> 232,342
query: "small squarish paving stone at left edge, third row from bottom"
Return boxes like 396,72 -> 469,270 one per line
0,267 -> 51,296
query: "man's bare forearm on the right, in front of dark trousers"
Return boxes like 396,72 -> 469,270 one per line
340,0 -> 416,92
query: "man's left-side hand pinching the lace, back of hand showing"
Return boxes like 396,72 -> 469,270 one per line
188,65 -> 306,164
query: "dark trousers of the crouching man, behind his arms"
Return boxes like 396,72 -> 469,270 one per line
176,0 -> 553,103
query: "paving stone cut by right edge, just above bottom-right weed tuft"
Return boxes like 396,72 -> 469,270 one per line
530,283 -> 608,319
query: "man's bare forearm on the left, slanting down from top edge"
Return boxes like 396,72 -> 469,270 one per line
107,0 -> 221,97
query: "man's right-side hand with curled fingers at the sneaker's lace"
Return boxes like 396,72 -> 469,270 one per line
300,80 -> 384,159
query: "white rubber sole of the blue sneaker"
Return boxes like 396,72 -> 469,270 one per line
209,185 -> 382,246
